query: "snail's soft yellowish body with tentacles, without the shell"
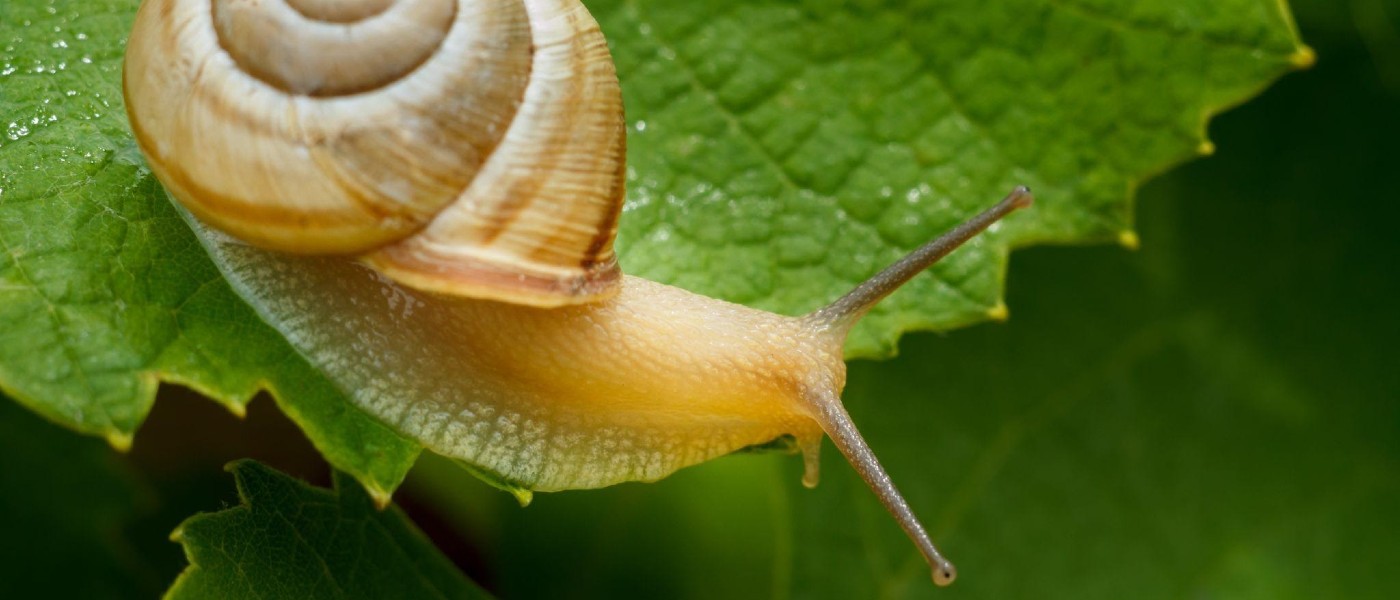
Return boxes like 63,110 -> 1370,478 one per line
185,189 -> 1030,585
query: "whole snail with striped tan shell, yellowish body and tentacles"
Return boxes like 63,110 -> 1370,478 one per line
123,0 -> 1030,585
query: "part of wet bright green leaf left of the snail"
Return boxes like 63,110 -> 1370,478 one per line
0,0 -> 419,492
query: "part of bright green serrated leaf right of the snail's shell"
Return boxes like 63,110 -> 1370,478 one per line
588,0 -> 1312,357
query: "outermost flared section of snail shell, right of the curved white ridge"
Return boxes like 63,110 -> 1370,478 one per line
365,0 -> 626,306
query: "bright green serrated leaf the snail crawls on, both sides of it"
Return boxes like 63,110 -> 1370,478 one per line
0,0 -> 1310,499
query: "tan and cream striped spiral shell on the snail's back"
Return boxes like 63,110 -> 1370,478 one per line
125,0 -> 626,306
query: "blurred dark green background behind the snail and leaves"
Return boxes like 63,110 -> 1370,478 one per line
0,0 -> 1400,599
